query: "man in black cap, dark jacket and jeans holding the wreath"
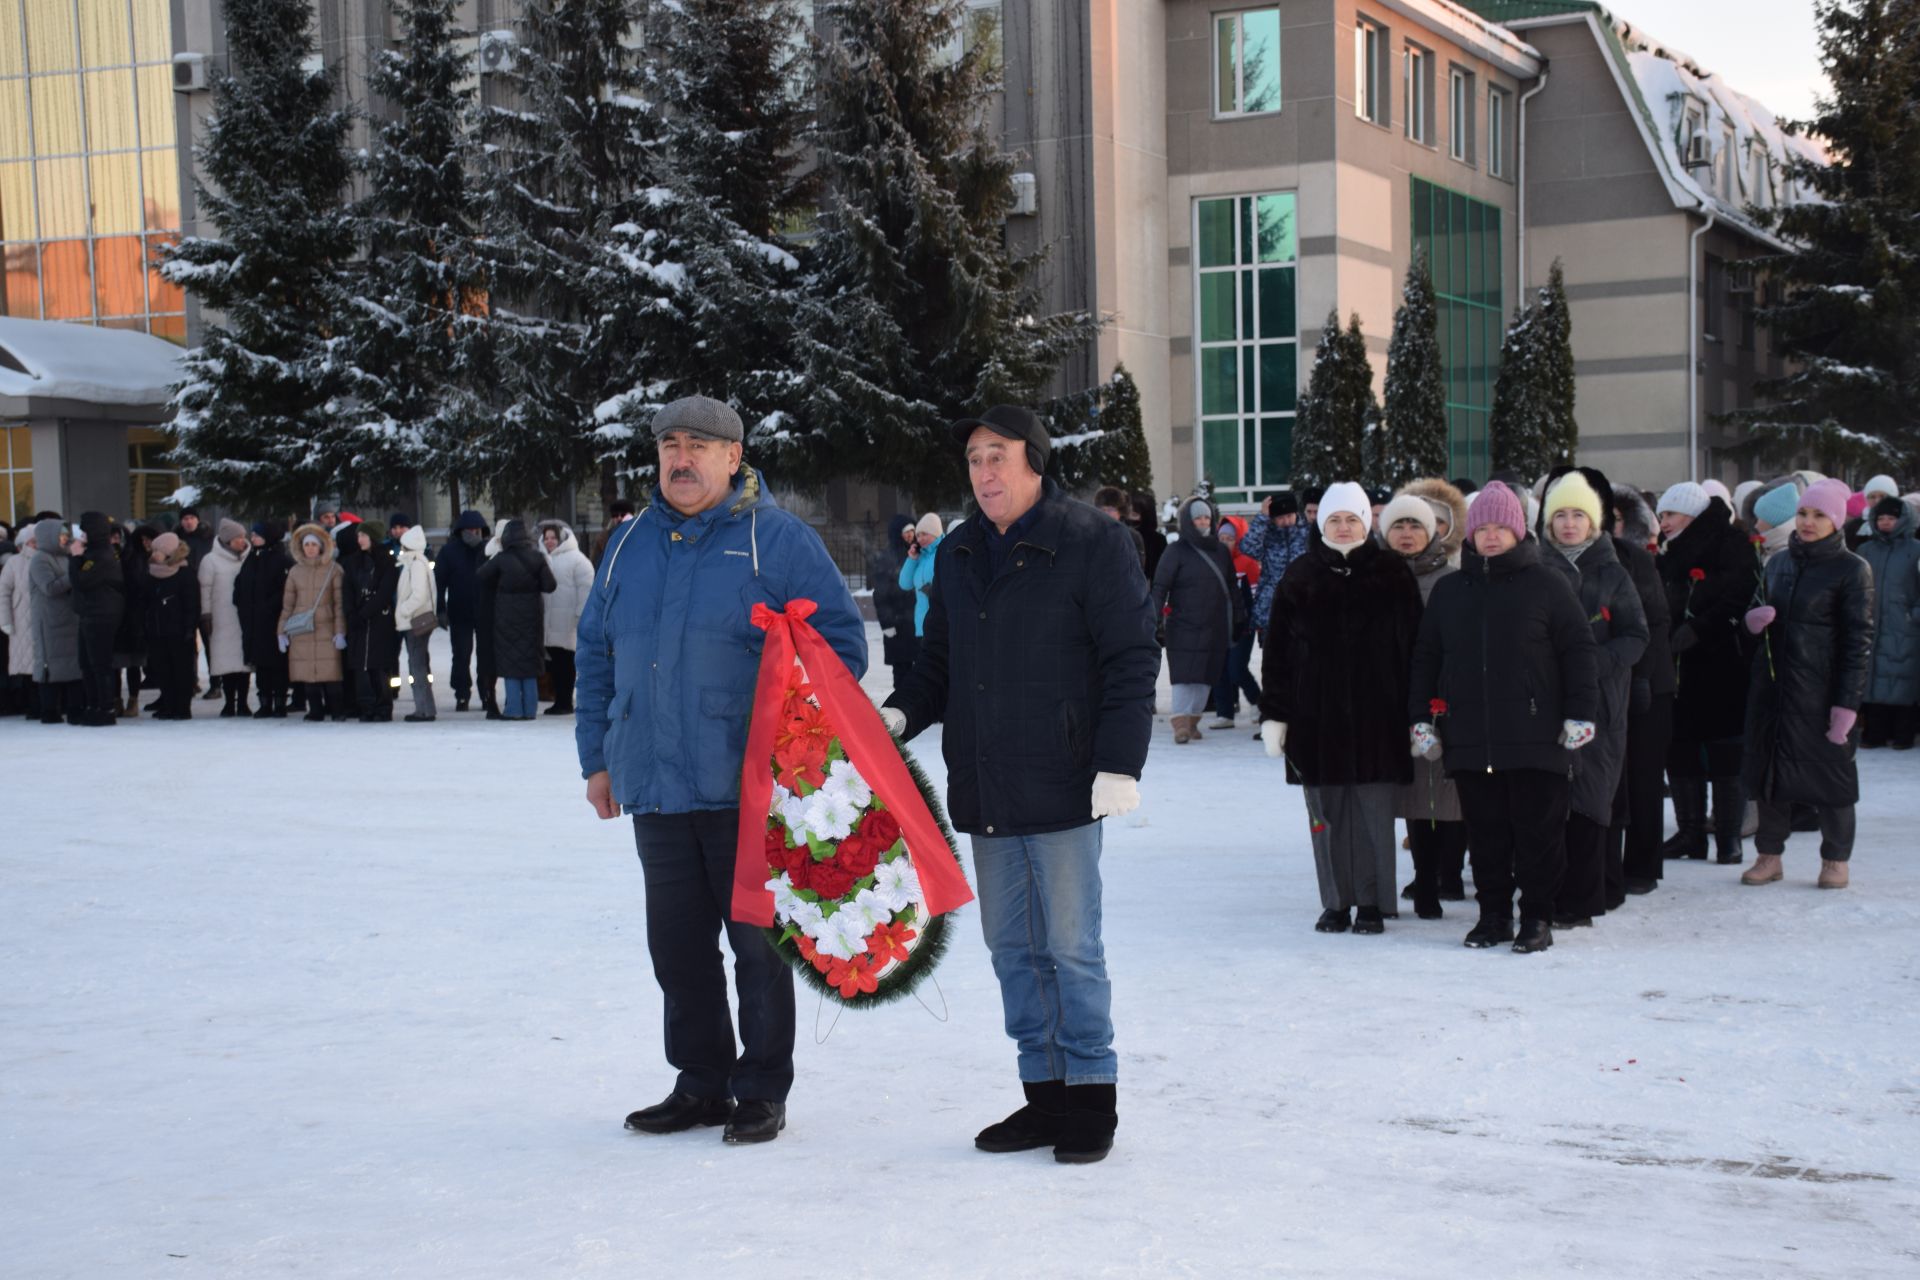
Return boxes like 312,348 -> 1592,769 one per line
881,405 -> 1160,1163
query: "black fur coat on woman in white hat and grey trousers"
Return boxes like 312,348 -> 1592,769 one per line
1259,539 -> 1438,787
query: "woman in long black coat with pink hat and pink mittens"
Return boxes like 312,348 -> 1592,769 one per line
1740,480 -> 1874,889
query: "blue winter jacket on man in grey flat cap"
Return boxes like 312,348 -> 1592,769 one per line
574,468 -> 866,814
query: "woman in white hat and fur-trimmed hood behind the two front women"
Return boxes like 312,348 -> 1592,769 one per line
1380,480 -> 1467,919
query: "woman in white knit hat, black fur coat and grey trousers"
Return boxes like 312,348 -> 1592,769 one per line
1259,484 -> 1421,933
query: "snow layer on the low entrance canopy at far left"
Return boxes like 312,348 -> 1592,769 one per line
0,317 -> 186,405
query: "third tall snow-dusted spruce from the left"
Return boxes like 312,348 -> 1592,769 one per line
468,0 -> 674,509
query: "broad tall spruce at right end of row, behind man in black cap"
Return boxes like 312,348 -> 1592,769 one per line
775,0 -> 1096,507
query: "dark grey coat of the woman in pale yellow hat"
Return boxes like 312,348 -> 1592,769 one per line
1540,533 -> 1647,827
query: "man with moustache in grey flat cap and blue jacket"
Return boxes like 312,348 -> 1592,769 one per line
574,395 -> 866,1142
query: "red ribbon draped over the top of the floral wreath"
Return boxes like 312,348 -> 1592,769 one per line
733,601 -> 973,927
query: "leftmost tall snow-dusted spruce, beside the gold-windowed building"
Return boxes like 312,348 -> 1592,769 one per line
159,0 -> 360,510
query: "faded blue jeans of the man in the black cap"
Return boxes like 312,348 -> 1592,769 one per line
970,821 -> 1119,1084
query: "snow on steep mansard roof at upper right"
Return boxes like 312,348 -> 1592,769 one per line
1619,25 -> 1832,223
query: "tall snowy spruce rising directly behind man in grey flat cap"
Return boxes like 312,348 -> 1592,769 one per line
599,0 -> 814,485
